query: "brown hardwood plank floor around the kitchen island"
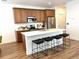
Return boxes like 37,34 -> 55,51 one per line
0,40 -> 79,59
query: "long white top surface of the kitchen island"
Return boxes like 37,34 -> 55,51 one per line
22,28 -> 65,37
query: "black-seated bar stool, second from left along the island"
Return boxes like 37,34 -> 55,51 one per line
44,36 -> 55,54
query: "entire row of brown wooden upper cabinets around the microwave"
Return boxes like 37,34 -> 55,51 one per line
13,8 -> 55,23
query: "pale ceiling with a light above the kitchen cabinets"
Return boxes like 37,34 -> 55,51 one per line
6,0 -> 72,8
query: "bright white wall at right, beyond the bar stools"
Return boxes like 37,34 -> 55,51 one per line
66,0 -> 79,40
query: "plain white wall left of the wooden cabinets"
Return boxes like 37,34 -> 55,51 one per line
0,2 -> 16,43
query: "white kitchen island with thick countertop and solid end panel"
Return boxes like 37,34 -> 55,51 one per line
22,28 -> 65,55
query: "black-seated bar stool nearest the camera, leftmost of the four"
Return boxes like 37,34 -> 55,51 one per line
32,39 -> 44,59
